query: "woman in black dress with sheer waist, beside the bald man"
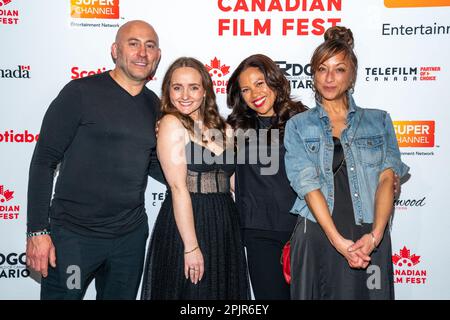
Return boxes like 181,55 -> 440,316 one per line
142,58 -> 249,299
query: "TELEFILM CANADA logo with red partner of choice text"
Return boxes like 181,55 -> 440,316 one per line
364,66 -> 442,82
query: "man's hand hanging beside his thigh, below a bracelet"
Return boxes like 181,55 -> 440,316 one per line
27,234 -> 56,278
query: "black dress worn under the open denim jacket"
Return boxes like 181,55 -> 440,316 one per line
291,137 -> 394,300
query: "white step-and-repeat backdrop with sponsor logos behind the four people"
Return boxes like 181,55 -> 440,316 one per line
0,0 -> 450,299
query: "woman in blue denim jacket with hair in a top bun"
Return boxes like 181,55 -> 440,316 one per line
284,27 -> 409,299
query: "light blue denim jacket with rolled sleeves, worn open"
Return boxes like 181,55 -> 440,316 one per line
284,95 -> 409,225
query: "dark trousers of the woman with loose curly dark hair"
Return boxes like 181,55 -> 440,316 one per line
243,229 -> 291,300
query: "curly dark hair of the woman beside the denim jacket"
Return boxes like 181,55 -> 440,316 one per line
227,54 -> 307,139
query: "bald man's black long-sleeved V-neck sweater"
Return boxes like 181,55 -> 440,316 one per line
28,71 -> 164,238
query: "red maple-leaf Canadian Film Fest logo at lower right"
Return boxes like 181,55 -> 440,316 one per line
392,246 -> 427,284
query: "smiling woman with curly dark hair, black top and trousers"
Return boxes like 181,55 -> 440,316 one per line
227,54 -> 305,300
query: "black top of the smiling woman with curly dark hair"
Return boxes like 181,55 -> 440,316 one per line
235,117 -> 297,232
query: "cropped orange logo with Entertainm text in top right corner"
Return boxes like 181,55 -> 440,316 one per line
381,0 -> 450,36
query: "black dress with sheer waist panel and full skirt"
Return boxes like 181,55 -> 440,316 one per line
141,142 -> 250,300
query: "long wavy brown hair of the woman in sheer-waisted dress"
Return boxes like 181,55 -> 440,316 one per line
161,57 -> 226,138
